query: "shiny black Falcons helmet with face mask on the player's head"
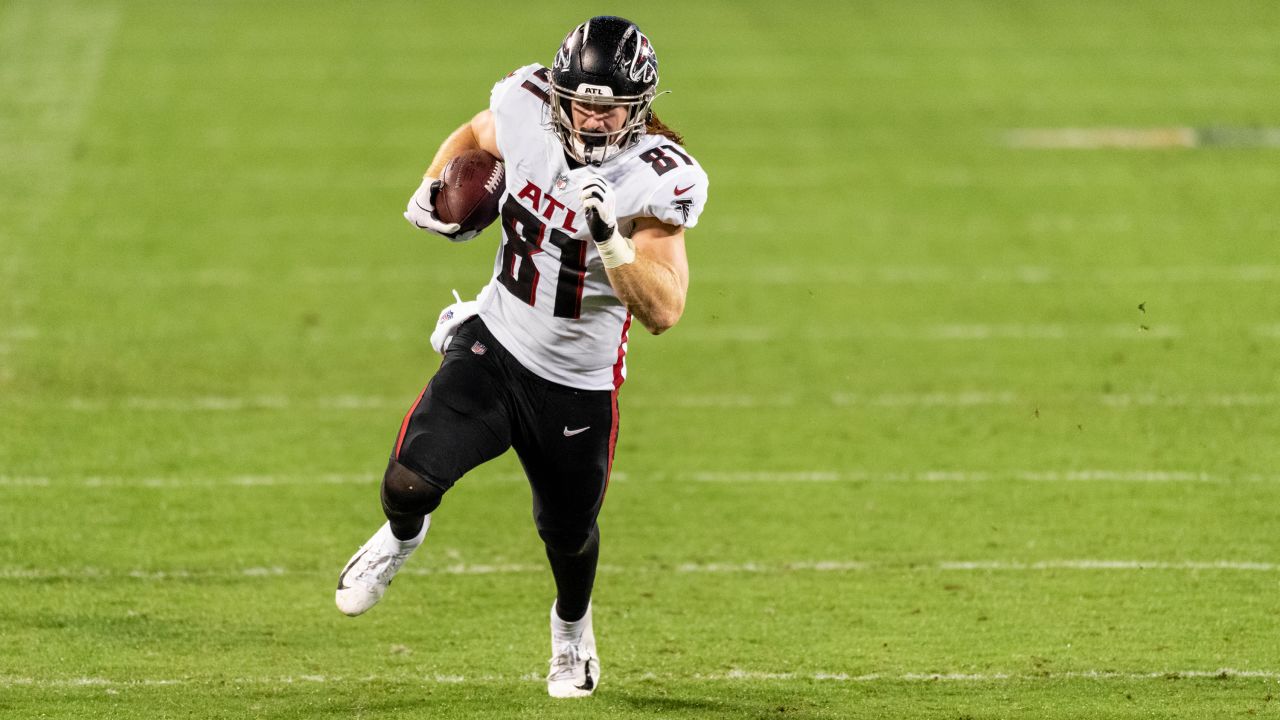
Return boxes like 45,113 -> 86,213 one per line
550,15 -> 658,165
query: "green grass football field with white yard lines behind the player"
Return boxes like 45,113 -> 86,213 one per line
0,0 -> 1280,720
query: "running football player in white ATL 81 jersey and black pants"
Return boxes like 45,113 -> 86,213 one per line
337,17 -> 707,697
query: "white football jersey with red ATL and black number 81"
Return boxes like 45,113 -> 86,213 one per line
480,65 -> 707,389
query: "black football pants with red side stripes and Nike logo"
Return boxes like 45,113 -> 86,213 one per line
393,318 -> 618,620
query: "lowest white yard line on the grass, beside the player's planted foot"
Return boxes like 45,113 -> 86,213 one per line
0,667 -> 1280,691
